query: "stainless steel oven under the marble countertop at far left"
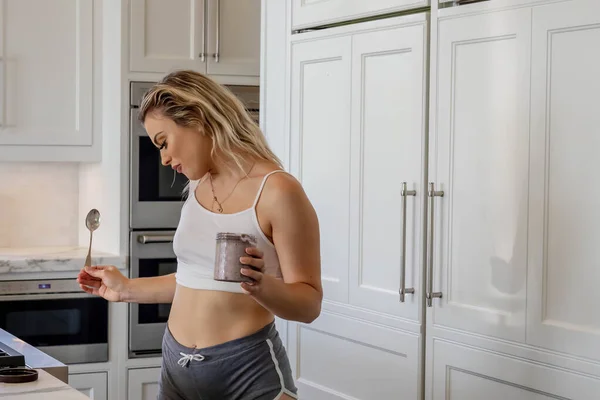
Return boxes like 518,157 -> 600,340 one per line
0,278 -> 108,364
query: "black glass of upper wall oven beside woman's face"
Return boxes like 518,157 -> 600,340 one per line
138,136 -> 188,201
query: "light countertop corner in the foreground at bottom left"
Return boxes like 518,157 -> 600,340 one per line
0,369 -> 89,400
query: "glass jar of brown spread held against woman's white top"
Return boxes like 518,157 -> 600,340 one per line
214,232 -> 256,282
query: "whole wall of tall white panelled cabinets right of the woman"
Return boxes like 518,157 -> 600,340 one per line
265,0 -> 600,400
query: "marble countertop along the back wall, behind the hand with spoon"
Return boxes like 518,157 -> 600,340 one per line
0,247 -> 126,274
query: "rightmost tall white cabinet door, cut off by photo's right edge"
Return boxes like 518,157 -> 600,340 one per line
523,1 -> 600,361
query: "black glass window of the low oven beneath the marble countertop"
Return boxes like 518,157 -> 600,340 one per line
0,297 -> 108,347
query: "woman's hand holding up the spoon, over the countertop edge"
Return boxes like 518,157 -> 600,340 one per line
77,265 -> 129,301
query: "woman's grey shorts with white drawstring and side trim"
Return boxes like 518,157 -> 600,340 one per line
158,322 -> 297,400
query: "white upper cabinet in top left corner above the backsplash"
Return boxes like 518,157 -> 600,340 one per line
0,0 -> 100,161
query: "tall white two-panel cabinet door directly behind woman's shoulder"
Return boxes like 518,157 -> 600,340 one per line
290,16 -> 426,320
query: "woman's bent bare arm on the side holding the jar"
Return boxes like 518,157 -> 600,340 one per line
242,174 -> 323,323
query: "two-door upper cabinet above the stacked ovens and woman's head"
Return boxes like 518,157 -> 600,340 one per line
129,0 -> 261,77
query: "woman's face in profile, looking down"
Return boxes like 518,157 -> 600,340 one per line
144,113 -> 212,180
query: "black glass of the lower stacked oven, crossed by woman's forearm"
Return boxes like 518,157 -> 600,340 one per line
138,258 -> 177,324
